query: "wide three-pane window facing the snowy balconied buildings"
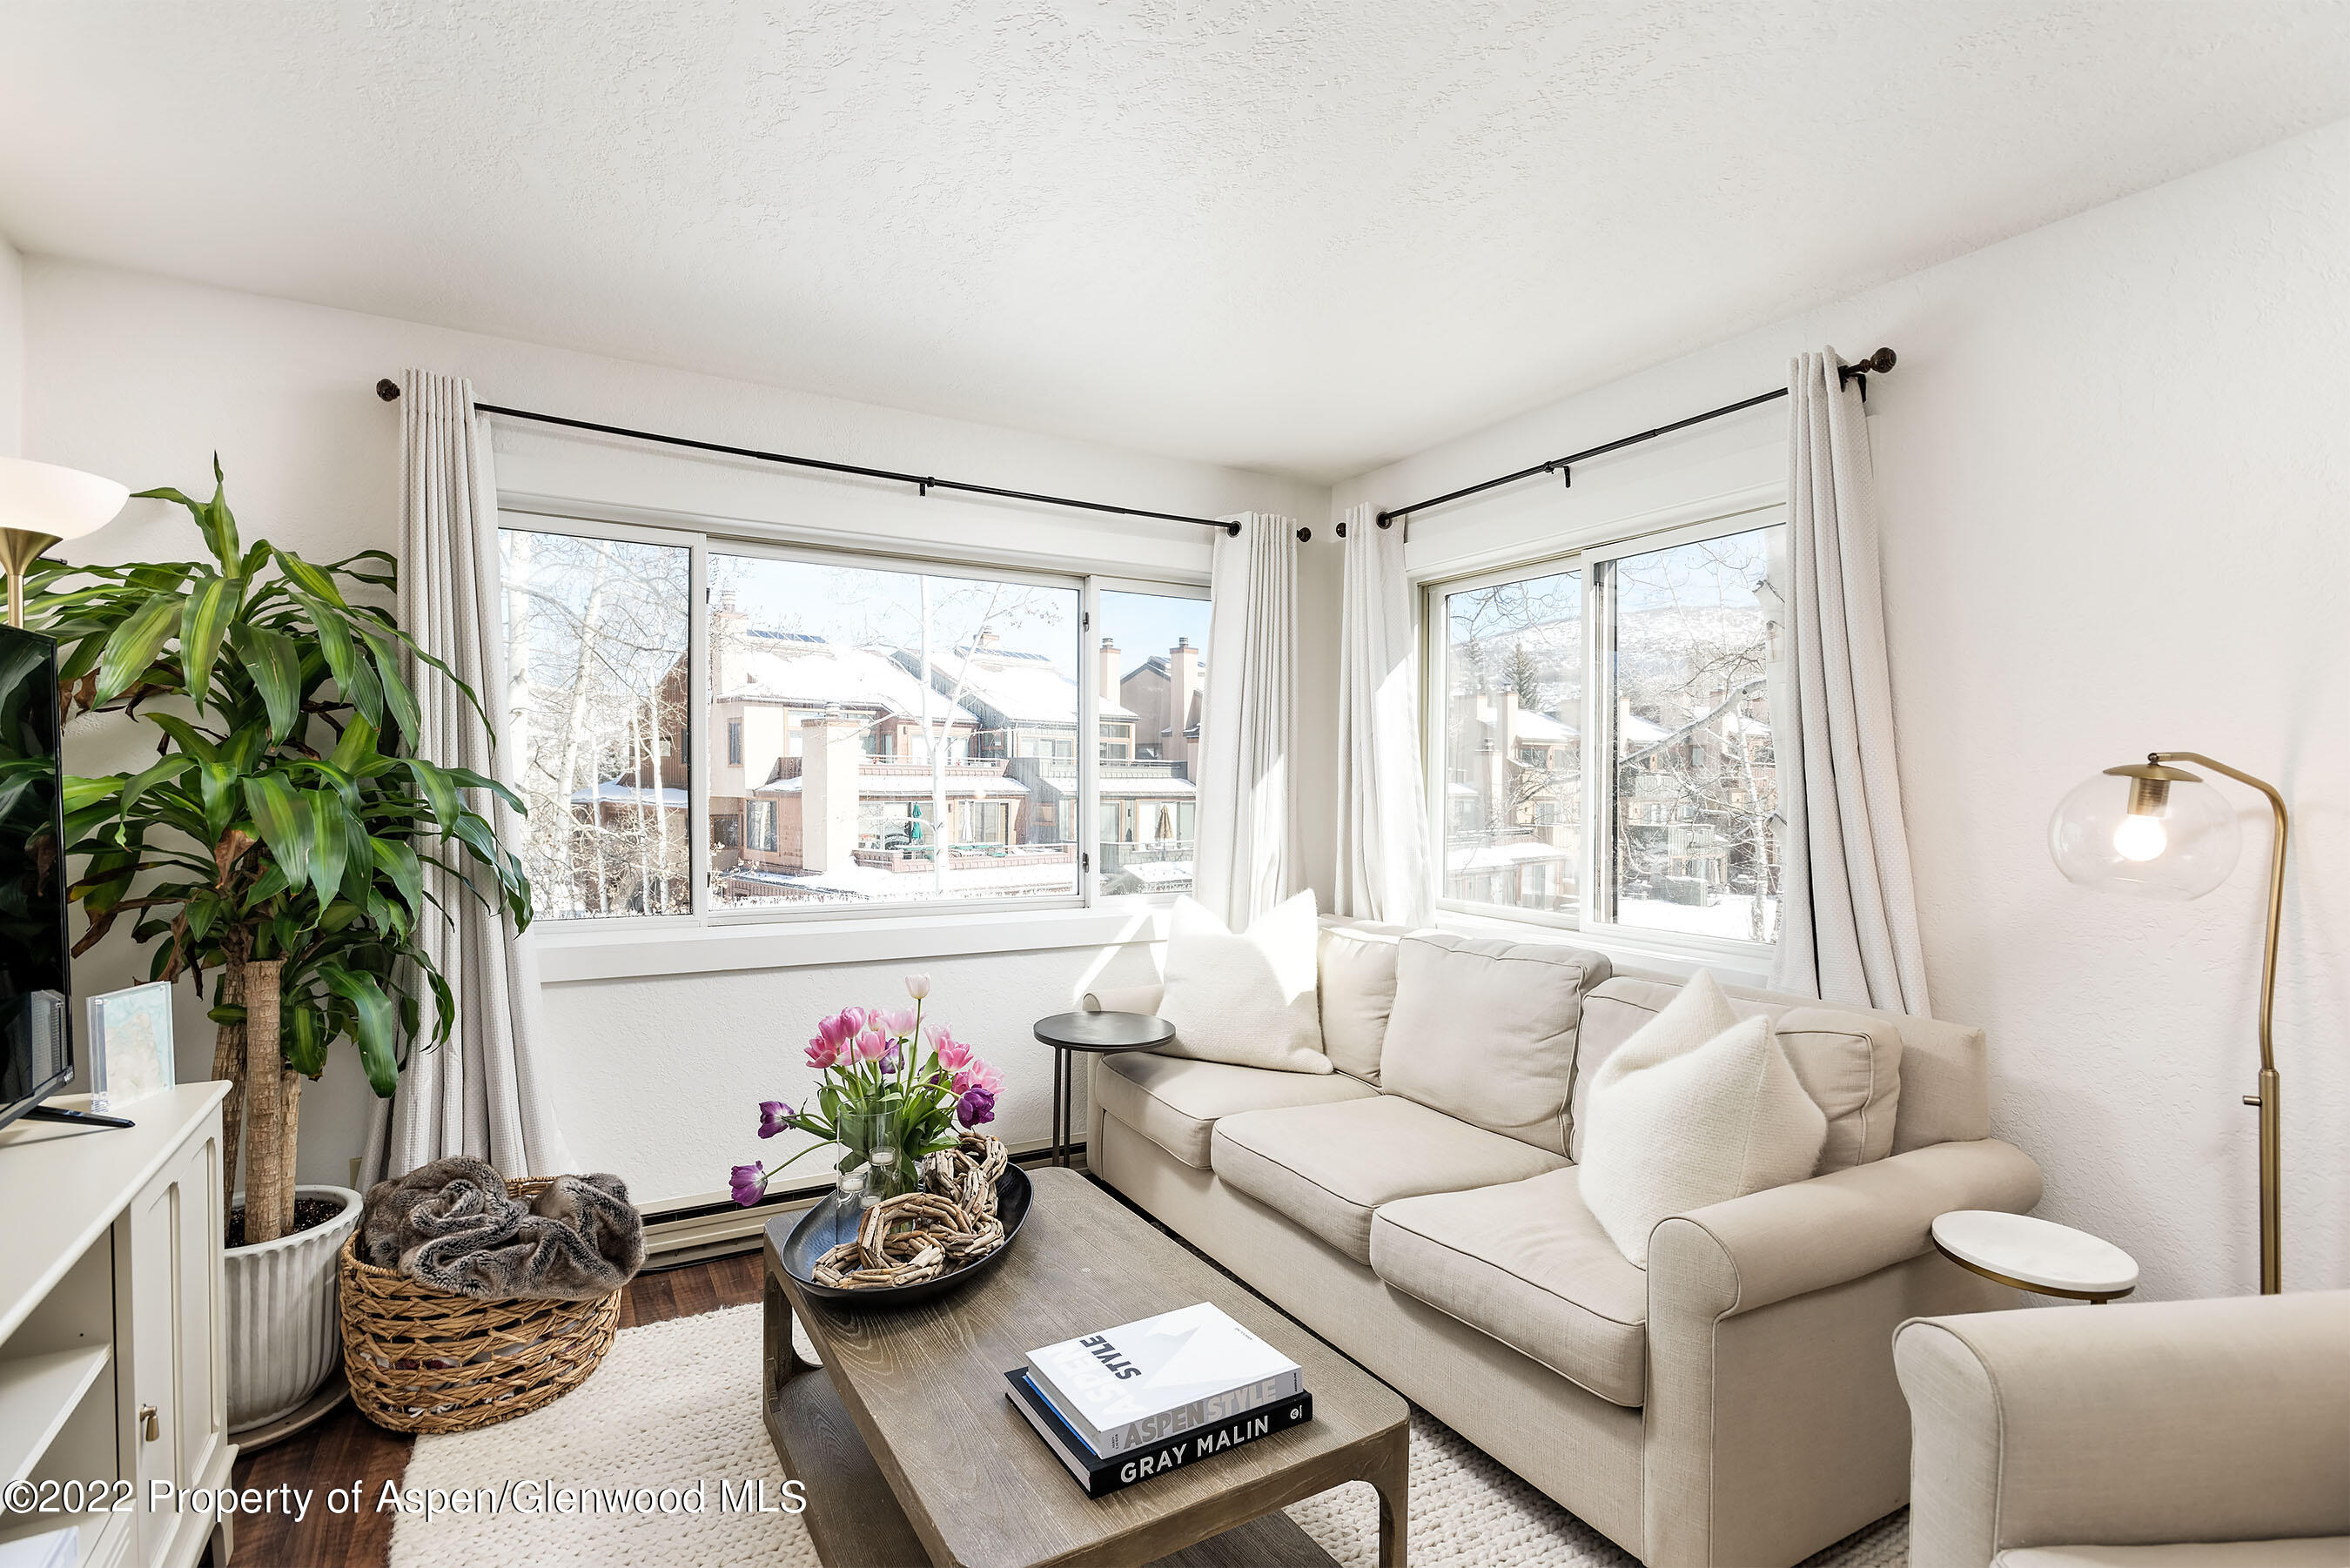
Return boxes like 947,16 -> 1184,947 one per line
500,515 -> 1208,919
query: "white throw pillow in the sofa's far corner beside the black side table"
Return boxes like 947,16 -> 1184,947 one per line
1158,894 -> 1330,1072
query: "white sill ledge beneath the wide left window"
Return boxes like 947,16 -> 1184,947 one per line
524,902 -> 1171,985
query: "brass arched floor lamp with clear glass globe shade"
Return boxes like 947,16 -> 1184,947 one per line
2049,753 -> 2286,1296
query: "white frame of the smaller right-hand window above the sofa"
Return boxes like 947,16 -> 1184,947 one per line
1413,493 -> 1786,968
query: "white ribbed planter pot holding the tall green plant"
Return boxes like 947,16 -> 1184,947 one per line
221,1187 -> 359,1434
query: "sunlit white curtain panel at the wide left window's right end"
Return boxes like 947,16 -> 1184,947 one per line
1192,513 -> 1299,931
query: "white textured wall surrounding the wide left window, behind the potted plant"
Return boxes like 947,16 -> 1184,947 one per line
23,256 -> 1337,1202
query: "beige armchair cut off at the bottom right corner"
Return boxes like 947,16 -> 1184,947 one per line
1894,1290 -> 2350,1568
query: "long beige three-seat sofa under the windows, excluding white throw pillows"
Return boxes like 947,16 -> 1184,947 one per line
1085,921 -> 2040,1568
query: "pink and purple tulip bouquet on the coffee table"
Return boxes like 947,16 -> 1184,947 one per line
731,975 -> 1004,1203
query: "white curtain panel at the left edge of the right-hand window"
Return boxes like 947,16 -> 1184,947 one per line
1337,506 -> 1429,926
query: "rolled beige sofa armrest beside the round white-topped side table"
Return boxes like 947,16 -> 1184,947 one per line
1648,1138 -> 2040,1317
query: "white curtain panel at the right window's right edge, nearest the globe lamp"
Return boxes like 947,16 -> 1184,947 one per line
1772,351 -> 1930,1013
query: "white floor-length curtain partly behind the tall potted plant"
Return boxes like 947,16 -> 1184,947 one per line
366,369 -> 571,1183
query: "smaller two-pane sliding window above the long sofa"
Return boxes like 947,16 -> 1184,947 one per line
1427,513 -> 1786,959
